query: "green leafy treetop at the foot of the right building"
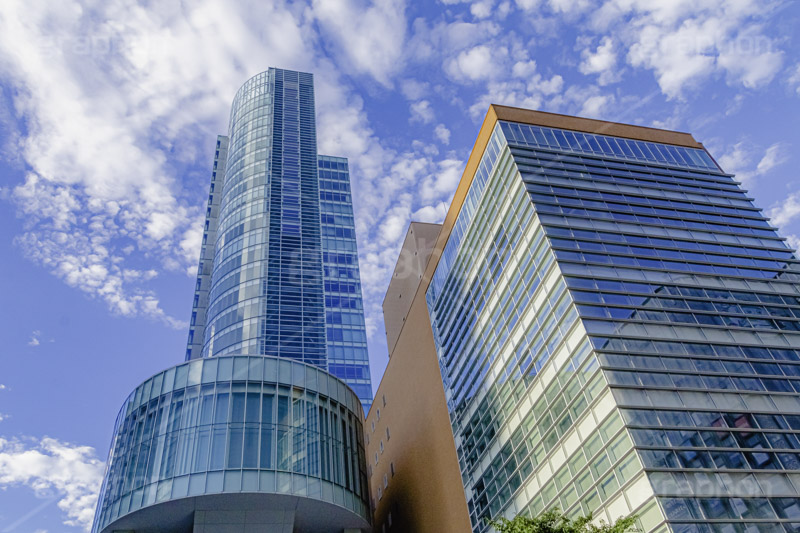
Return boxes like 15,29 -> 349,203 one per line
489,508 -> 636,533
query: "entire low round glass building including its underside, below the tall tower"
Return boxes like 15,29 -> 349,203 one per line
92,356 -> 370,533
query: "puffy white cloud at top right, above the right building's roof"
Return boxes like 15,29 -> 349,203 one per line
591,0 -> 783,98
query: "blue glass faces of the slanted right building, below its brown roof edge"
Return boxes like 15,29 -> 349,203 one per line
427,122 -> 800,533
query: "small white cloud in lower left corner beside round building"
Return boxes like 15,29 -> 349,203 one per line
0,437 -> 105,531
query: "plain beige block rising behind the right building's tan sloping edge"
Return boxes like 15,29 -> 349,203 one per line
383,222 -> 442,356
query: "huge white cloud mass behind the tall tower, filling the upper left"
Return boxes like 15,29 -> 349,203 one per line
0,0 -> 388,328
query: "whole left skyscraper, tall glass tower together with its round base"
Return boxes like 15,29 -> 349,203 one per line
94,69 -> 372,533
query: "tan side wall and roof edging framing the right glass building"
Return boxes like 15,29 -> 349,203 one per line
364,105 -> 703,533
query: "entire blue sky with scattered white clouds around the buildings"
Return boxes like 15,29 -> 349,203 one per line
0,0 -> 800,533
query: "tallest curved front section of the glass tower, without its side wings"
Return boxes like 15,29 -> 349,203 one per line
203,69 -> 327,368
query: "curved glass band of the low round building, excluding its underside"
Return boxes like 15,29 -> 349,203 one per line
94,356 -> 369,531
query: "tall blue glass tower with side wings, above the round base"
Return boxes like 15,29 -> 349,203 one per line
186,69 -> 372,412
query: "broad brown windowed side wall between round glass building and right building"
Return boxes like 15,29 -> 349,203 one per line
365,274 -> 471,533
